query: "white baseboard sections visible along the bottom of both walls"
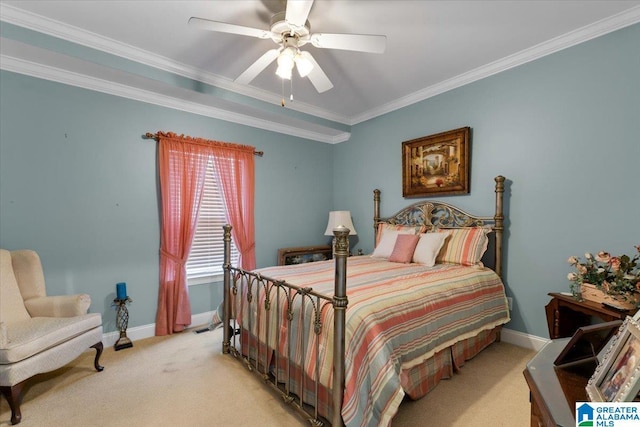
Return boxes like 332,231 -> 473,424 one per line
102,311 -> 549,351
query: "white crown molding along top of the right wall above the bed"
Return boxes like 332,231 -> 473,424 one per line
350,6 -> 640,125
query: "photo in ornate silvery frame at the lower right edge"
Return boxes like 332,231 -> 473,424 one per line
587,316 -> 640,402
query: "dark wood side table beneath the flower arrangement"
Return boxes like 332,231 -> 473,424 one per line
545,292 -> 635,339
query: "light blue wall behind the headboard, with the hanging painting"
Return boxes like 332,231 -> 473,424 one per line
334,24 -> 640,337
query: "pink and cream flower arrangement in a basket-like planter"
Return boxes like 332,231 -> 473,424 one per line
567,245 -> 640,301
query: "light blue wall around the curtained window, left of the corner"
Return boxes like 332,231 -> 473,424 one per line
0,72 -> 333,331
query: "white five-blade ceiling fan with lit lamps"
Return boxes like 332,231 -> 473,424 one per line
189,0 -> 387,93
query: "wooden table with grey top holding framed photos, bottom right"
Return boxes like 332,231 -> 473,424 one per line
523,338 -> 596,427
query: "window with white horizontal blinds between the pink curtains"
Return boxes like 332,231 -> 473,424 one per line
187,160 -> 238,285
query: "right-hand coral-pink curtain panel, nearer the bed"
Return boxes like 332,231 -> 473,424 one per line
213,144 -> 256,270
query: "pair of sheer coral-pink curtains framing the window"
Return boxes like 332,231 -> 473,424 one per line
156,132 -> 255,335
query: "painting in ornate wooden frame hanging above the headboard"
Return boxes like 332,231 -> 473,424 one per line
402,127 -> 470,197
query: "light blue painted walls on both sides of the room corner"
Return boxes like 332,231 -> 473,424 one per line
0,24 -> 640,337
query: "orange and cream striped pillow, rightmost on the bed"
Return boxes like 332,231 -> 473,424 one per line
436,227 -> 492,265
